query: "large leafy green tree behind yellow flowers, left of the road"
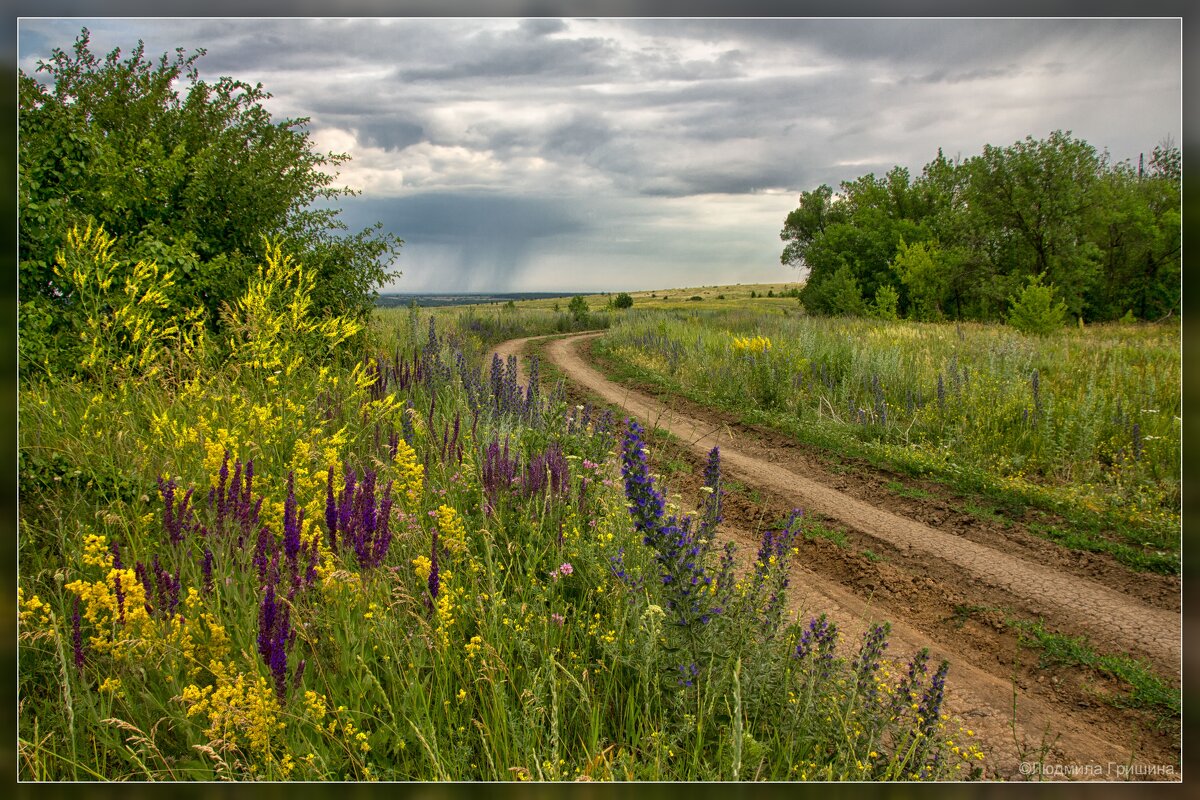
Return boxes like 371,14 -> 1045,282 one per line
18,29 -> 403,371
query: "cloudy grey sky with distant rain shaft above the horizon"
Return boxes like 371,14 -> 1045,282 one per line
17,17 -> 1183,293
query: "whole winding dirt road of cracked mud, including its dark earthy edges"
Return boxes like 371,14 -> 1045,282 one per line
493,332 -> 1182,780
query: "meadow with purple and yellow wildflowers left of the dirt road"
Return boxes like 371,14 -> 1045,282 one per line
18,261 -> 983,781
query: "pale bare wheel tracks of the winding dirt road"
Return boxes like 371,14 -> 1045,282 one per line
493,332 -> 1182,780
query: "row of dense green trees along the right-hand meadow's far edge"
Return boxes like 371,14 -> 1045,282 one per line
780,131 -> 1182,321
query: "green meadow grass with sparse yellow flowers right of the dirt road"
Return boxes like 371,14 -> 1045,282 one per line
595,307 -> 1181,572
